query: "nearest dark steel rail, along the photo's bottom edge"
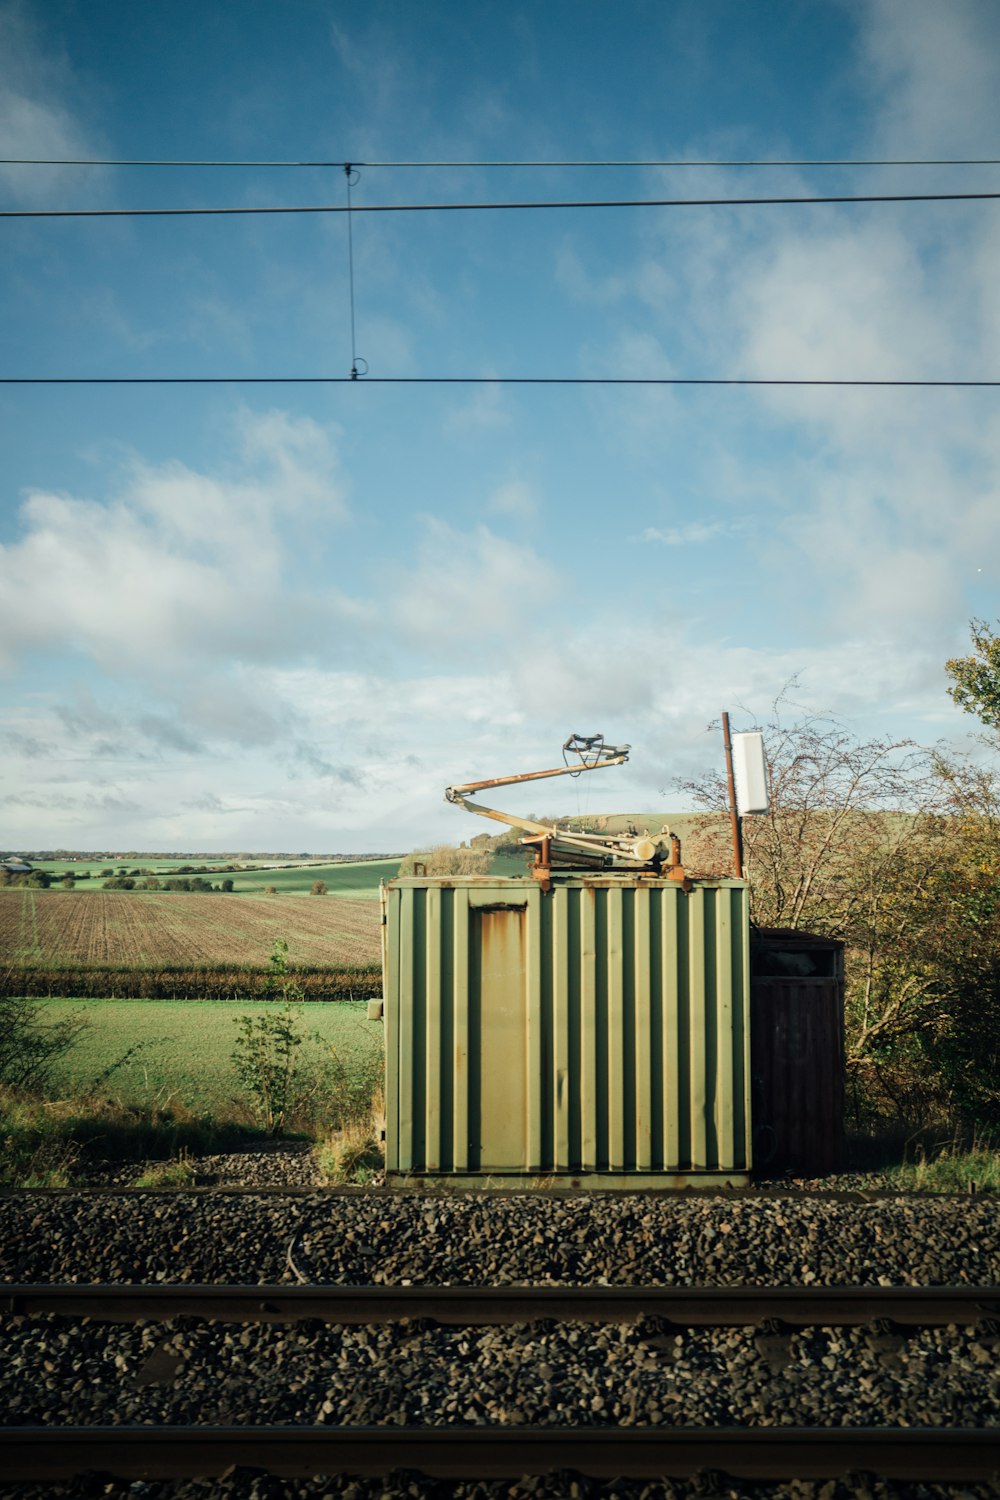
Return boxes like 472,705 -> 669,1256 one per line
0,1427 -> 1000,1482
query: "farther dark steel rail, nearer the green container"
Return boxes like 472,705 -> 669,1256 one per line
0,1283 -> 1000,1328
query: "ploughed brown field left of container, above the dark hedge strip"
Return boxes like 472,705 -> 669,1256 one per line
0,890 -> 379,969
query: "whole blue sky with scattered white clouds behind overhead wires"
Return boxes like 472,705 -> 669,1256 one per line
0,0 -> 1000,852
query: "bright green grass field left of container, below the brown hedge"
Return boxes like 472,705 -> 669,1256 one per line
37,1001 -> 382,1118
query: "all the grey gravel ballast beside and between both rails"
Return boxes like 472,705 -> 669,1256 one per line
0,1190 -> 1000,1500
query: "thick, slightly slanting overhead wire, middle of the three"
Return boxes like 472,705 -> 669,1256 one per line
0,192 -> 1000,219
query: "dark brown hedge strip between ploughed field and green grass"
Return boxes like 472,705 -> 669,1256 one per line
0,963 -> 382,1001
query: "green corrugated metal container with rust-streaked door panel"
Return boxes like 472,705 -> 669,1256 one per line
384,873 -> 751,1188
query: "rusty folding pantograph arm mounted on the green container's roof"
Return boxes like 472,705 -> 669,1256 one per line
444,735 -> 690,890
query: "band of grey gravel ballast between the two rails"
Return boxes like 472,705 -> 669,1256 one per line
0,1316 -> 1000,1427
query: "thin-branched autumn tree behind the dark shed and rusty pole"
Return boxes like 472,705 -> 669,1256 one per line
671,702 -> 976,1113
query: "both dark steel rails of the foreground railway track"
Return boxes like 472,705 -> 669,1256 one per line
0,1283 -> 1000,1482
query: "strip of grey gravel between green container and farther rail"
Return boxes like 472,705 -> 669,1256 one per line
0,1191 -> 1000,1286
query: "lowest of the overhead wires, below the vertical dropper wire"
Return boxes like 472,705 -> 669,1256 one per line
0,375 -> 1000,390
